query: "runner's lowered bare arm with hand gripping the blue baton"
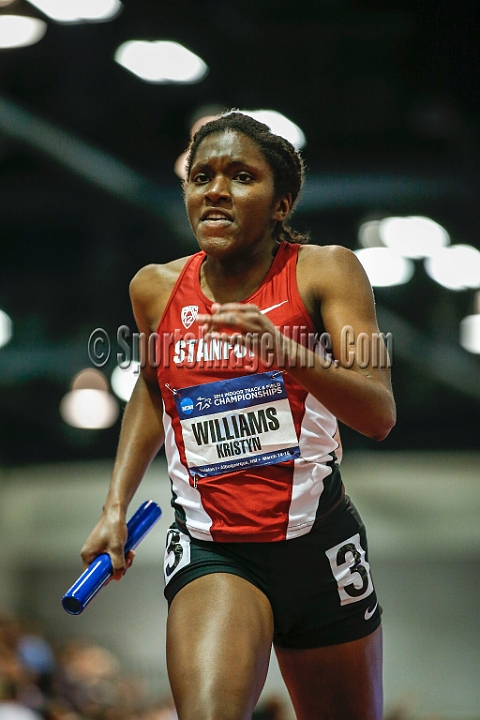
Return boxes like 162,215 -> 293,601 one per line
81,266 -> 169,580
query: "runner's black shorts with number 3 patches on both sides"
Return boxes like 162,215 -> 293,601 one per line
164,496 -> 381,648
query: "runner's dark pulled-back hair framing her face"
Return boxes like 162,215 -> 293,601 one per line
185,111 -> 309,244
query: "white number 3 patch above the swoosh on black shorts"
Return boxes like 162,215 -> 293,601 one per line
325,533 -> 373,605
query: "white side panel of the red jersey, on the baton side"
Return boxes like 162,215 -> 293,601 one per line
163,412 -> 213,540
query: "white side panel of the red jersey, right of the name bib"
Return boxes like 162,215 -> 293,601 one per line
286,393 -> 338,540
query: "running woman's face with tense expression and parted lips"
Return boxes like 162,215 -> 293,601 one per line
185,131 -> 286,257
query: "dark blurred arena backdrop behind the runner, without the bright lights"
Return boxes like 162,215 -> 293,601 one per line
0,0 -> 480,465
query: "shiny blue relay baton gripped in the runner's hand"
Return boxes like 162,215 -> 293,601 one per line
62,500 -> 162,615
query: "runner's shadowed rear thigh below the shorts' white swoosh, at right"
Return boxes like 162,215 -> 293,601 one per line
275,627 -> 383,720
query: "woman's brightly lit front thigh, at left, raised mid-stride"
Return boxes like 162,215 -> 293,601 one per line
167,573 -> 273,720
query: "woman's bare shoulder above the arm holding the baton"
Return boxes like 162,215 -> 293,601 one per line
130,256 -> 191,329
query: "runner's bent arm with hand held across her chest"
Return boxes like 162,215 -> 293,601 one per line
197,247 -> 396,440
